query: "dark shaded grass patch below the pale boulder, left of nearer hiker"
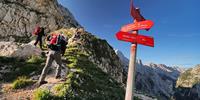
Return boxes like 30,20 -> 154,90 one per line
0,56 -> 45,82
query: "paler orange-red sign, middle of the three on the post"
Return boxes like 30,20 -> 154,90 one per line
120,20 -> 154,32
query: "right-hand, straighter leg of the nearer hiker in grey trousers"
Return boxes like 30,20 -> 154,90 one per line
55,52 -> 62,77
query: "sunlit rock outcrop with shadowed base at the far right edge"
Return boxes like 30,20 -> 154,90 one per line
173,65 -> 200,100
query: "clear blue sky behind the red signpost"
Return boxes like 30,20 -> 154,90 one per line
58,0 -> 200,68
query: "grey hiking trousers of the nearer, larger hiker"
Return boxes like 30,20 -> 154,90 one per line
38,50 -> 62,83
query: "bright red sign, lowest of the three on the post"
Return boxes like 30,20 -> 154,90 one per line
116,31 -> 154,47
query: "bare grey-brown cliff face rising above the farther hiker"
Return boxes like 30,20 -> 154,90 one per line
0,0 -> 80,42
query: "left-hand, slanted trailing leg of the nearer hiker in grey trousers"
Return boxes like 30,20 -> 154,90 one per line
38,51 -> 54,83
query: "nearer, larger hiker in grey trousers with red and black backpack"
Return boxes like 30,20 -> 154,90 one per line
37,33 -> 68,86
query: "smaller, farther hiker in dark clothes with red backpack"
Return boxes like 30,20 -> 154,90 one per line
33,26 -> 45,50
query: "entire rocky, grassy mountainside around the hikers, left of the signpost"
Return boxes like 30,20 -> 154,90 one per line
0,0 -> 124,100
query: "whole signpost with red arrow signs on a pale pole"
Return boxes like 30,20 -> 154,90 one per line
116,0 -> 154,100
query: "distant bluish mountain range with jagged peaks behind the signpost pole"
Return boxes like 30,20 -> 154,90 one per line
116,51 -> 183,100
